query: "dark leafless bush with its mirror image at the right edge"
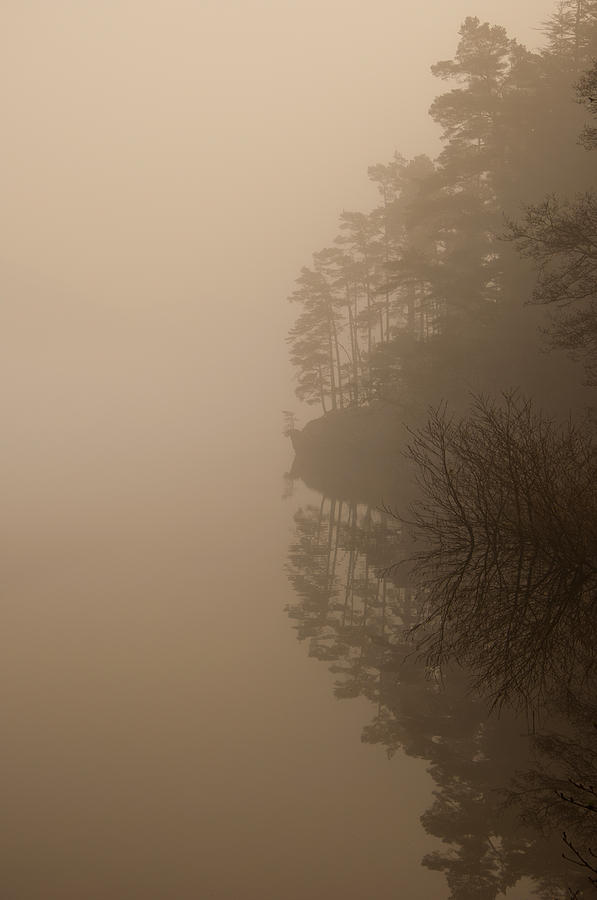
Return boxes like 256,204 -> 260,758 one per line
410,395 -> 597,704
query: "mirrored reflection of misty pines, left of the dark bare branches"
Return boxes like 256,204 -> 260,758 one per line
287,498 -> 588,900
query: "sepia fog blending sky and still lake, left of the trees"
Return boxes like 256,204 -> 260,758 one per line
0,0 -> 572,900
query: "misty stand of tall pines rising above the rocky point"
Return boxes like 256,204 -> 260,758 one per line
288,0 -> 597,412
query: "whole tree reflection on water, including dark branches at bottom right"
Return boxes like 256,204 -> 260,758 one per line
287,495 -> 597,900
